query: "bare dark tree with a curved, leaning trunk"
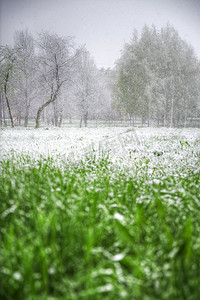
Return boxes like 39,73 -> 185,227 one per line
36,32 -> 79,128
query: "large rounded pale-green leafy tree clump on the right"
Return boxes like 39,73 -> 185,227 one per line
113,24 -> 200,127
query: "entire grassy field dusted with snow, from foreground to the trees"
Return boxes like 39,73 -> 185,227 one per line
0,128 -> 200,300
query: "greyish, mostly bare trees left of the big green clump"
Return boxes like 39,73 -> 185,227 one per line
0,30 -> 112,128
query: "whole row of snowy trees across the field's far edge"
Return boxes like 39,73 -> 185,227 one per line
0,24 -> 200,128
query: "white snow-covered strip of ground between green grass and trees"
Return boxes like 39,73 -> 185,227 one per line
0,127 -> 200,175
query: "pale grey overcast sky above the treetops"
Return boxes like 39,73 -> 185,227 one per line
0,0 -> 200,68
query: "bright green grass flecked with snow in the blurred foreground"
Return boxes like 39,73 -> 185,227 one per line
0,157 -> 200,300
